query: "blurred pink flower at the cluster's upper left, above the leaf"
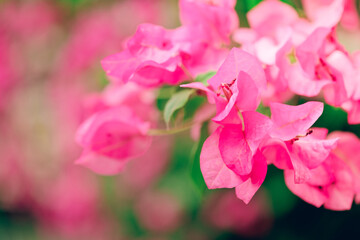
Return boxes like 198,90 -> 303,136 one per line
102,24 -> 183,87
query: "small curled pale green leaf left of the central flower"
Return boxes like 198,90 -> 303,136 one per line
164,89 -> 194,124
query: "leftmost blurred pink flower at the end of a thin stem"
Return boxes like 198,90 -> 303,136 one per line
76,106 -> 152,165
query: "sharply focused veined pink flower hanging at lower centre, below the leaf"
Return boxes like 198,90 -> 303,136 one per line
200,112 -> 272,203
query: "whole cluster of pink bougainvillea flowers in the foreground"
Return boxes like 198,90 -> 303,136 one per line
77,0 -> 360,210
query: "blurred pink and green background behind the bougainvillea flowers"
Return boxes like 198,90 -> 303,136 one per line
0,0 -> 360,240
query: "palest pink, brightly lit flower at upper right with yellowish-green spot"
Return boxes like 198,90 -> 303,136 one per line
234,0 -> 347,106
